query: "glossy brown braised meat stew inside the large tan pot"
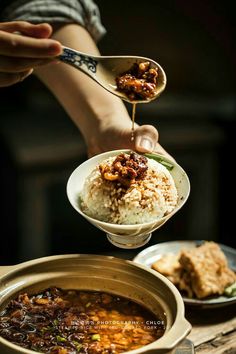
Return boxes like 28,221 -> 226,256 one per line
0,288 -> 165,354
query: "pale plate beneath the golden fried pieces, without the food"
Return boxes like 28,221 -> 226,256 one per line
133,241 -> 236,307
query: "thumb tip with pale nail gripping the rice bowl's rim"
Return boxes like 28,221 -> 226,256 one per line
134,125 -> 158,152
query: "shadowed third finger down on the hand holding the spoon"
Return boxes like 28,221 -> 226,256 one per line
0,55 -> 56,73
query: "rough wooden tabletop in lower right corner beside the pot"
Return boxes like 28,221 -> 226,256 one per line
186,304 -> 236,354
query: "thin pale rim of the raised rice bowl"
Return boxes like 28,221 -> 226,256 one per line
66,149 -> 191,230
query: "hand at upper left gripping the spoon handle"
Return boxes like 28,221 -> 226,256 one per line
0,21 -> 62,87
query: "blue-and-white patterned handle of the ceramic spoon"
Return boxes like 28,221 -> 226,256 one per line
58,47 -> 98,80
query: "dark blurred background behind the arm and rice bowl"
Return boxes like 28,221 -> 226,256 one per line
0,0 -> 236,264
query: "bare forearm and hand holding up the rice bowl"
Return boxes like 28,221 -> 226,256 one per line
32,24 -> 172,159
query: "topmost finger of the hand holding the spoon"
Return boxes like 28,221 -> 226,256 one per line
0,21 -> 52,38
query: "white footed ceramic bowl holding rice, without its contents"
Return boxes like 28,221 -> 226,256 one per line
67,150 -> 190,248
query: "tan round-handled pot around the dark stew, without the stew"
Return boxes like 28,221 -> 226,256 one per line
0,254 -> 191,354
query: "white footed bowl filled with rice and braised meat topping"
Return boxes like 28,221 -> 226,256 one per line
67,150 -> 190,248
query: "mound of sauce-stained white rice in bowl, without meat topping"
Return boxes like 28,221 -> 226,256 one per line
80,157 -> 178,225
